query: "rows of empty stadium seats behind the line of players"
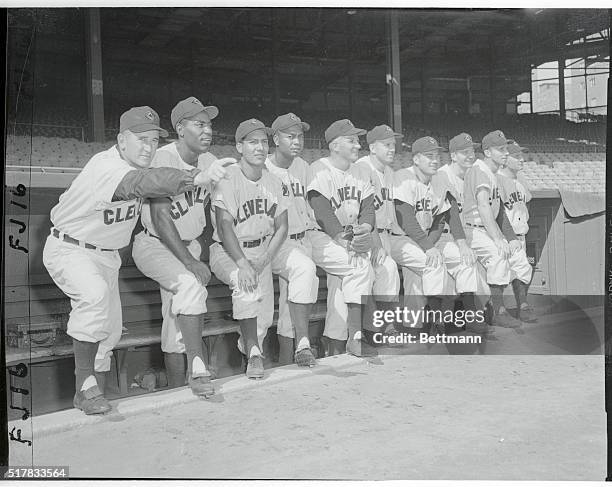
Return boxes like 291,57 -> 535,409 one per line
6,114 -> 606,193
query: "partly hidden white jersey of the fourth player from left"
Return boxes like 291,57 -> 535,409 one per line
266,157 -> 315,234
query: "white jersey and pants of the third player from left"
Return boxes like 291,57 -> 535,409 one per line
210,164 -> 289,353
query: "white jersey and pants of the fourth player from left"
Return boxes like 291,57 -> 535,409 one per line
266,157 -> 319,338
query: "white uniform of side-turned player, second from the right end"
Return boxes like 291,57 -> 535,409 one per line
463,159 -> 510,286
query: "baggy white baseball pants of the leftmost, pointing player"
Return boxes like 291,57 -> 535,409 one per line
43,235 -> 122,372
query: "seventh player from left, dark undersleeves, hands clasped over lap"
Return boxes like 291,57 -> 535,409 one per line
391,137 -> 482,332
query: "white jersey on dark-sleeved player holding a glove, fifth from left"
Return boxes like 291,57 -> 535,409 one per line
308,157 -> 374,230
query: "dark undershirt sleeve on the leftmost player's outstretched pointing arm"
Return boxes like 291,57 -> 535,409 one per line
113,167 -> 198,201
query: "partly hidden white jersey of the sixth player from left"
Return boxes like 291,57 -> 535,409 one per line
355,156 -> 401,234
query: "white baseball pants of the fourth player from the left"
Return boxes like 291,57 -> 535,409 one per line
272,238 -> 319,338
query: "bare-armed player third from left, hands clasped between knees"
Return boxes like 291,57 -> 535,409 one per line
210,118 -> 288,379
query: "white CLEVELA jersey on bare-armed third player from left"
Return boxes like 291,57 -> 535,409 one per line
212,164 -> 289,242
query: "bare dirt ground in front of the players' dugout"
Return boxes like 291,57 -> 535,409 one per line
10,355 -> 606,480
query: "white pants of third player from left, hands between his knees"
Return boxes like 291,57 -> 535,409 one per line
210,241 -> 274,354
